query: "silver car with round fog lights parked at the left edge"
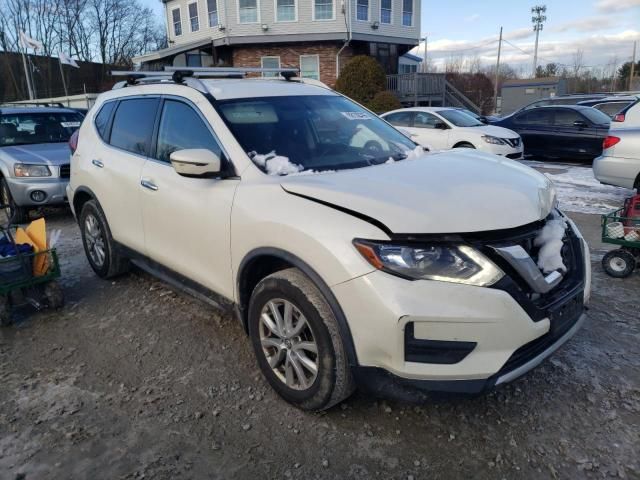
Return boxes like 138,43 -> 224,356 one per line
0,107 -> 83,223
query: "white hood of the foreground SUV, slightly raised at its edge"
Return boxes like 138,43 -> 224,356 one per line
281,150 -> 555,234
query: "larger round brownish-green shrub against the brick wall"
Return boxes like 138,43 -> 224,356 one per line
336,55 -> 387,105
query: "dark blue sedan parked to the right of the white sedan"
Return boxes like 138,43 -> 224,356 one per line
493,105 -> 610,160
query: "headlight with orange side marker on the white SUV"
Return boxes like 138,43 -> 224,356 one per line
353,239 -> 504,287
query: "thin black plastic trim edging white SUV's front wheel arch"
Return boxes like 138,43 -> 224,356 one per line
236,247 -> 358,366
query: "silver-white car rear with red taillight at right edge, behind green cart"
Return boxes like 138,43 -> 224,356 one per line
593,126 -> 640,190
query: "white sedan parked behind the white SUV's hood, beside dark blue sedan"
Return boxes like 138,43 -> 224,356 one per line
381,107 -> 523,159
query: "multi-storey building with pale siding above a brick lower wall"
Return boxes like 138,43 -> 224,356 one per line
134,0 -> 420,85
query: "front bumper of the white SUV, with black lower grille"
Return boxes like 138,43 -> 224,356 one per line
333,212 -> 590,399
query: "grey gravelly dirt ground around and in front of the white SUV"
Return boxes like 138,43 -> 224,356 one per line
0,208 -> 640,480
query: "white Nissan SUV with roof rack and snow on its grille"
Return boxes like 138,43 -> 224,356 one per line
68,70 -> 590,410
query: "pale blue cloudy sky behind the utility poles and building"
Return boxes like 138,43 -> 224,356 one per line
143,0 -> 640,74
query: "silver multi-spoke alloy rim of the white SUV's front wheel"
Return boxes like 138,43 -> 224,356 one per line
259,299 -> 318,390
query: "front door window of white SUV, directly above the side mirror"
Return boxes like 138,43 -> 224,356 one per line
155,100 -> 223,162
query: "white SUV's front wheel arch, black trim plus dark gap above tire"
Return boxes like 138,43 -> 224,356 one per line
236,247 -> 358,366
